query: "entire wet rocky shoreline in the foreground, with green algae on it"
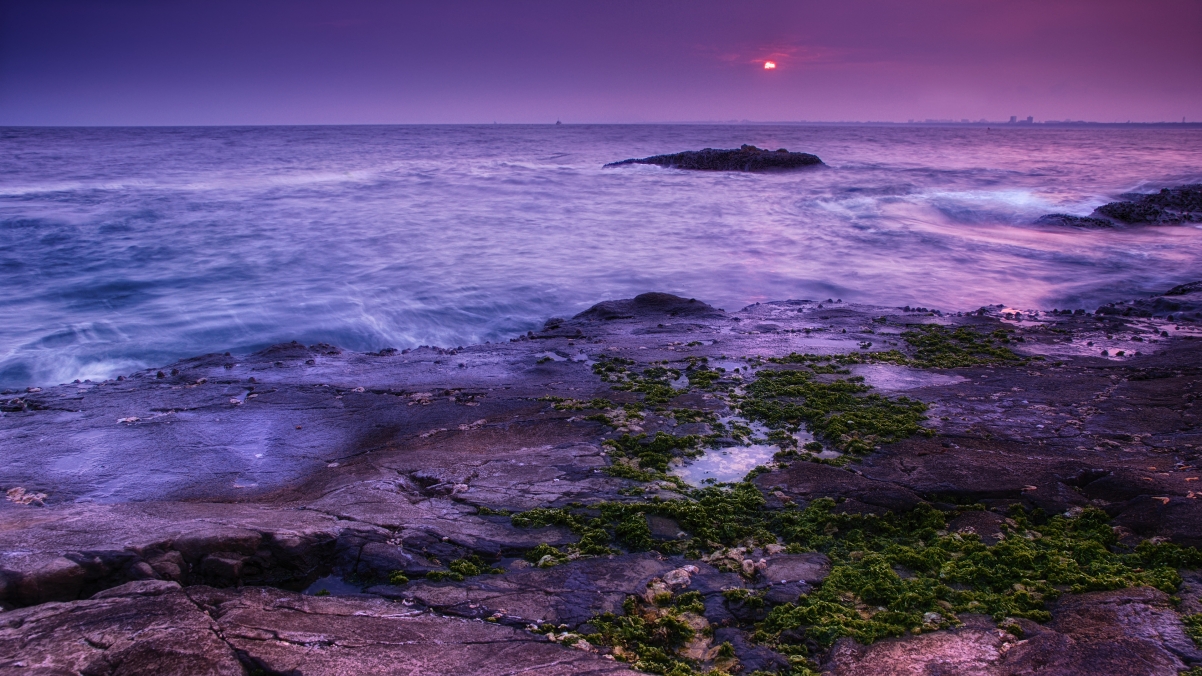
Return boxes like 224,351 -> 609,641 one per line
0,283 -> 1202,675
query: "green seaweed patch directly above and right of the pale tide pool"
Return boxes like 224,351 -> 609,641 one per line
739,370 -> 934,455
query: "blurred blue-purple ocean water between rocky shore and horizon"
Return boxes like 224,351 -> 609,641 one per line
0,125 -> 1202,387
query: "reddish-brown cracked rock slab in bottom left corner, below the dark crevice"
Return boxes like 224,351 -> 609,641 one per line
0,586 -> 630,676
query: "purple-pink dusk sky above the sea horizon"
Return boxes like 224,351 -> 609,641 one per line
0,0 -> 1202,125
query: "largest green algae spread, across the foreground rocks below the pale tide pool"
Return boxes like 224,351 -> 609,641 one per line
502,481 -> 1202,675
